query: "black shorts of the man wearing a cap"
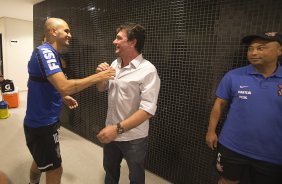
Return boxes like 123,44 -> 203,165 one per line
216,145 -> 282,184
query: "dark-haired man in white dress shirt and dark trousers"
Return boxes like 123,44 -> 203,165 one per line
96,23 -> 160,184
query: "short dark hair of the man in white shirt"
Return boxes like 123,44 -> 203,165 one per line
116,22 -> 146,53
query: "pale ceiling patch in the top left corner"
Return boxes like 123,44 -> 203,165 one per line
0,0 -> 44,21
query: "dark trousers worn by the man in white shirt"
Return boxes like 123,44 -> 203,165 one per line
103,137 -> 148,184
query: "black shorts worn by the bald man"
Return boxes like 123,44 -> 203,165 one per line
24,123 -> 62,172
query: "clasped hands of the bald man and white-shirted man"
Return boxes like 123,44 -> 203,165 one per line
96,62 -> 116,80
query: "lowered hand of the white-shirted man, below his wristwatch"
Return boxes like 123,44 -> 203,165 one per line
97,125 -> 118,144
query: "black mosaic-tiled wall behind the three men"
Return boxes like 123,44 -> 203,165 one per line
34,0 -> 282,184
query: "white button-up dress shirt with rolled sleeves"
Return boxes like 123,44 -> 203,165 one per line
106,54 -> 160,141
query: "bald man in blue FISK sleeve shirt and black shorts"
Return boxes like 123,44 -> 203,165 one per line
24,18 -> 115,184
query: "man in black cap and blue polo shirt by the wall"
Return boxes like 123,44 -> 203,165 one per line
206,32 -> 282,184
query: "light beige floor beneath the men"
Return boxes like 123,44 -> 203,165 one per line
0,92 -> 169,184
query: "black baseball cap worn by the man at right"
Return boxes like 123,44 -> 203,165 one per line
242,32 -> 282,45
